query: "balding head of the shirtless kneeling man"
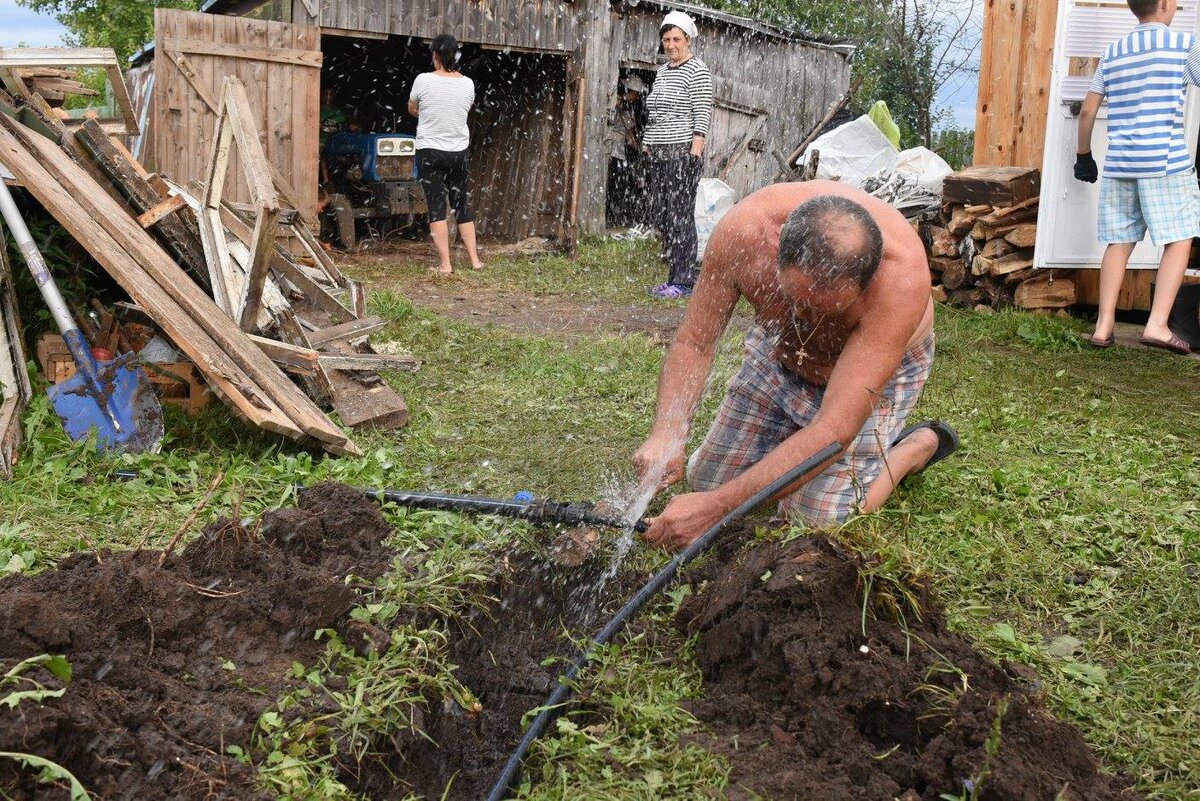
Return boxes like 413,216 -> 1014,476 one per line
779,194 -> 883,290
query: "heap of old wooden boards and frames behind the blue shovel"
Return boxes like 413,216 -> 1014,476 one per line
0,53 -> 420,464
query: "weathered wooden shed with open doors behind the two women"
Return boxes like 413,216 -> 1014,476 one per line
131,0 -> 853,240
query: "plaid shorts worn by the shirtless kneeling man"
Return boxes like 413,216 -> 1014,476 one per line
688,325 -> 934,525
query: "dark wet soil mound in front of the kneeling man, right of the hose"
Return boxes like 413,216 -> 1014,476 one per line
678,540 -> 1139,801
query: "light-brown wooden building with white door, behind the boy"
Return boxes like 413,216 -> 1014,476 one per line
974,0 -> 1200,311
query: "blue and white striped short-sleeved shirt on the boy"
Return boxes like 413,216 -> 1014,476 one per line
1090,23 -> 1200,177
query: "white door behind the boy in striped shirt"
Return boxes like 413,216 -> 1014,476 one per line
1033,0 -> 1200,270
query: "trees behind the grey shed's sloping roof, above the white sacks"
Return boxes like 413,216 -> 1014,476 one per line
703,0 -> 978,147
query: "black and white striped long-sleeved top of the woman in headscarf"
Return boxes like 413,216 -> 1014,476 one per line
642,56 -> 713,145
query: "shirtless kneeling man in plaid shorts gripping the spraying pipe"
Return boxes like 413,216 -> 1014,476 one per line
634,181 -> 958,549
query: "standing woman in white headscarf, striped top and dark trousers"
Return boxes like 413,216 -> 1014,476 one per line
642,11 -> 713,297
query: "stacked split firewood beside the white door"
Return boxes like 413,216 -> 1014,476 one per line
922,167 -> 1075,309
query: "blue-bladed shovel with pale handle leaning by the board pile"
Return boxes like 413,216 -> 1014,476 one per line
0,181 -> 163,453
